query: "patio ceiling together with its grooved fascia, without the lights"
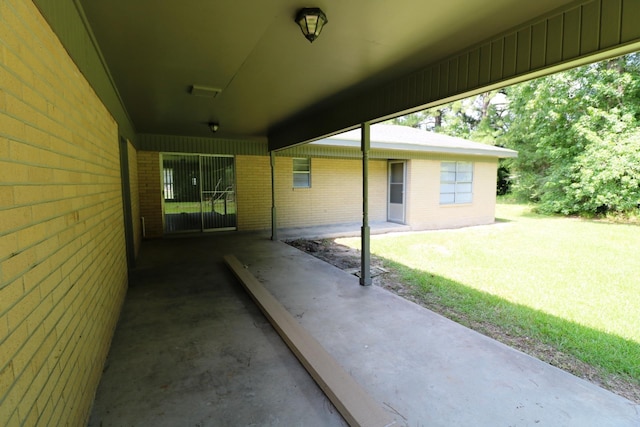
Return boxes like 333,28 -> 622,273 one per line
34,0 -> 640,150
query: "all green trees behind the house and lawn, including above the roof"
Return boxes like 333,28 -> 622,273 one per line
392,53 -> 640,216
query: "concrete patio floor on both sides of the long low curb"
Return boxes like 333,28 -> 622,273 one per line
89,233 -> 640,427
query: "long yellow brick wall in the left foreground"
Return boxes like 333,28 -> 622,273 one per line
0,0 -> 127,426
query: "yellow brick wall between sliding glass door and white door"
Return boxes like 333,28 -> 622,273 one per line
236,156 -> 387,230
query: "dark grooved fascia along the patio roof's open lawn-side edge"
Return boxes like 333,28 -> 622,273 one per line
269,0 -> 640,150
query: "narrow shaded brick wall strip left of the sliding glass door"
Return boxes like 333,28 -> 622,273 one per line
138,151 -> 164,238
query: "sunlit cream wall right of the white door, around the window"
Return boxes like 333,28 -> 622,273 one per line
407,157 -> 498,230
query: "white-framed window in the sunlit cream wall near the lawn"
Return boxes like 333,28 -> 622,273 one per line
440,161 -> 474,205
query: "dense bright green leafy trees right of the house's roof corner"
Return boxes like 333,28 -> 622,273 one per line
504,54 -> 640,215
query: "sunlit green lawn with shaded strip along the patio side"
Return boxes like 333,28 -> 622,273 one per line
338,203 -> 640,382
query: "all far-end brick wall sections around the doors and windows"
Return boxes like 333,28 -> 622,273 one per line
134,151 -> 498,238
